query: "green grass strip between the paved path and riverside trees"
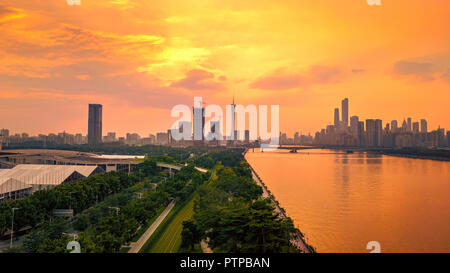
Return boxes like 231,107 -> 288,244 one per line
149,198 -> 194,253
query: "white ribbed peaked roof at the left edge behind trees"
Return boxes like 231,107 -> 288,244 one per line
0,164 -> 97,193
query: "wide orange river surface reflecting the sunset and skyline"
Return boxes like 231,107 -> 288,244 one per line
246,150 -> 450,252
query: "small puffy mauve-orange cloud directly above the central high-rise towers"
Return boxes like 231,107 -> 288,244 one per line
171,69 -> 225,91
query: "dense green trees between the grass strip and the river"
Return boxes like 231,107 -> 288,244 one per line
182,151 -> 297,253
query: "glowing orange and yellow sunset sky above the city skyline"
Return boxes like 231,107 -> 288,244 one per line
0,0 -> 450,136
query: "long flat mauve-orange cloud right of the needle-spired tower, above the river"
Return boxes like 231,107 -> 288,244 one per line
250,65 -> 342,90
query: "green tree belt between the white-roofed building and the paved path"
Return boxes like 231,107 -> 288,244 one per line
7,160 -> 205,253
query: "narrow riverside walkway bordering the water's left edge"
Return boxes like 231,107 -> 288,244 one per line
243,150 -> 316,253
